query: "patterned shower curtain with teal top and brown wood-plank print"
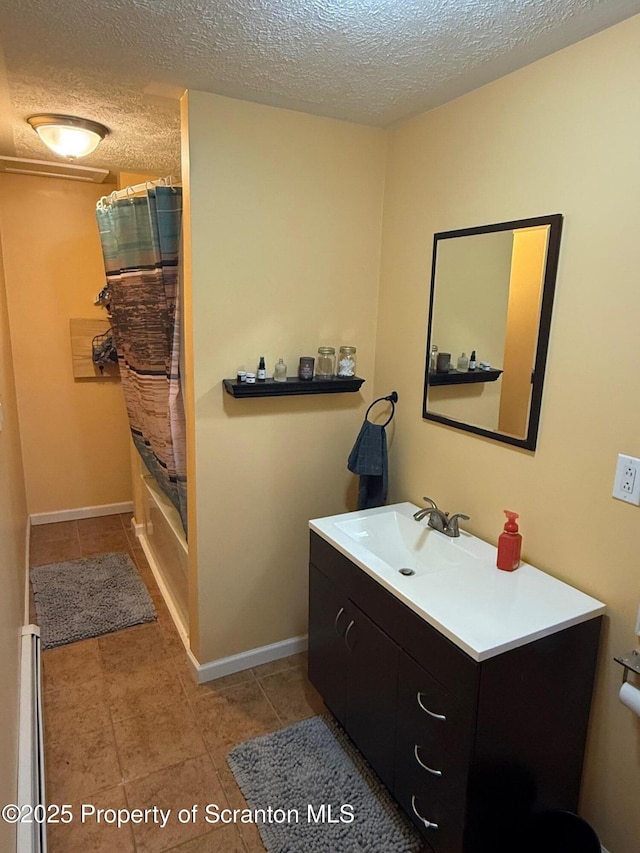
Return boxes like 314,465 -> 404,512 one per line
96,187 -> 187,531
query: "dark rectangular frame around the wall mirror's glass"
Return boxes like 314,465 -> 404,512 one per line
422,213 -> 562,450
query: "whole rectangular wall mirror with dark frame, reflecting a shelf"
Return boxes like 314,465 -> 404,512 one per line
423,214 -> 562,450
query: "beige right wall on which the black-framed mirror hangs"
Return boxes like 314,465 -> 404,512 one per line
375,17 -> 640,853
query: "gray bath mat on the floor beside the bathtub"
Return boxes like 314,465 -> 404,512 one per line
31,553 -> 156,649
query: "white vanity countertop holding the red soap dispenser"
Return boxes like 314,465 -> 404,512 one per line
309,503 -> 606,661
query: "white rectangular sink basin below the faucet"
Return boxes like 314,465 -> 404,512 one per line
335,509 -> 476,577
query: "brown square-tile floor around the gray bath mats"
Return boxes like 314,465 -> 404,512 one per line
31,515 -> 324,853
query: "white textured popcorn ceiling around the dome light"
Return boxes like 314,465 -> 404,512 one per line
0,0 -> 640,178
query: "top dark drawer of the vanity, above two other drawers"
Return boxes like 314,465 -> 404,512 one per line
398,655 -> 476,767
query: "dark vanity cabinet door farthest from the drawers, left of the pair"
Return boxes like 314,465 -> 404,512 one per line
309,564 -> 349,726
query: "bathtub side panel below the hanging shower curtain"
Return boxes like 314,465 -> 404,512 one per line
136,472 -> 189,646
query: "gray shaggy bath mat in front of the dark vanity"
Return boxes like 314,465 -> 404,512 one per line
227,717 -> 424,853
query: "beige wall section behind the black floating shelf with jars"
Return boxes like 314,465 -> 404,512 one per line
183,92 -> 392,662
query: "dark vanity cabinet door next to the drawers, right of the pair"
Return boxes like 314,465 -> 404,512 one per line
345,603 -> 399,790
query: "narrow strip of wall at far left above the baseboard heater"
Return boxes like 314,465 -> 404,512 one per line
0,198 -> 27,850
